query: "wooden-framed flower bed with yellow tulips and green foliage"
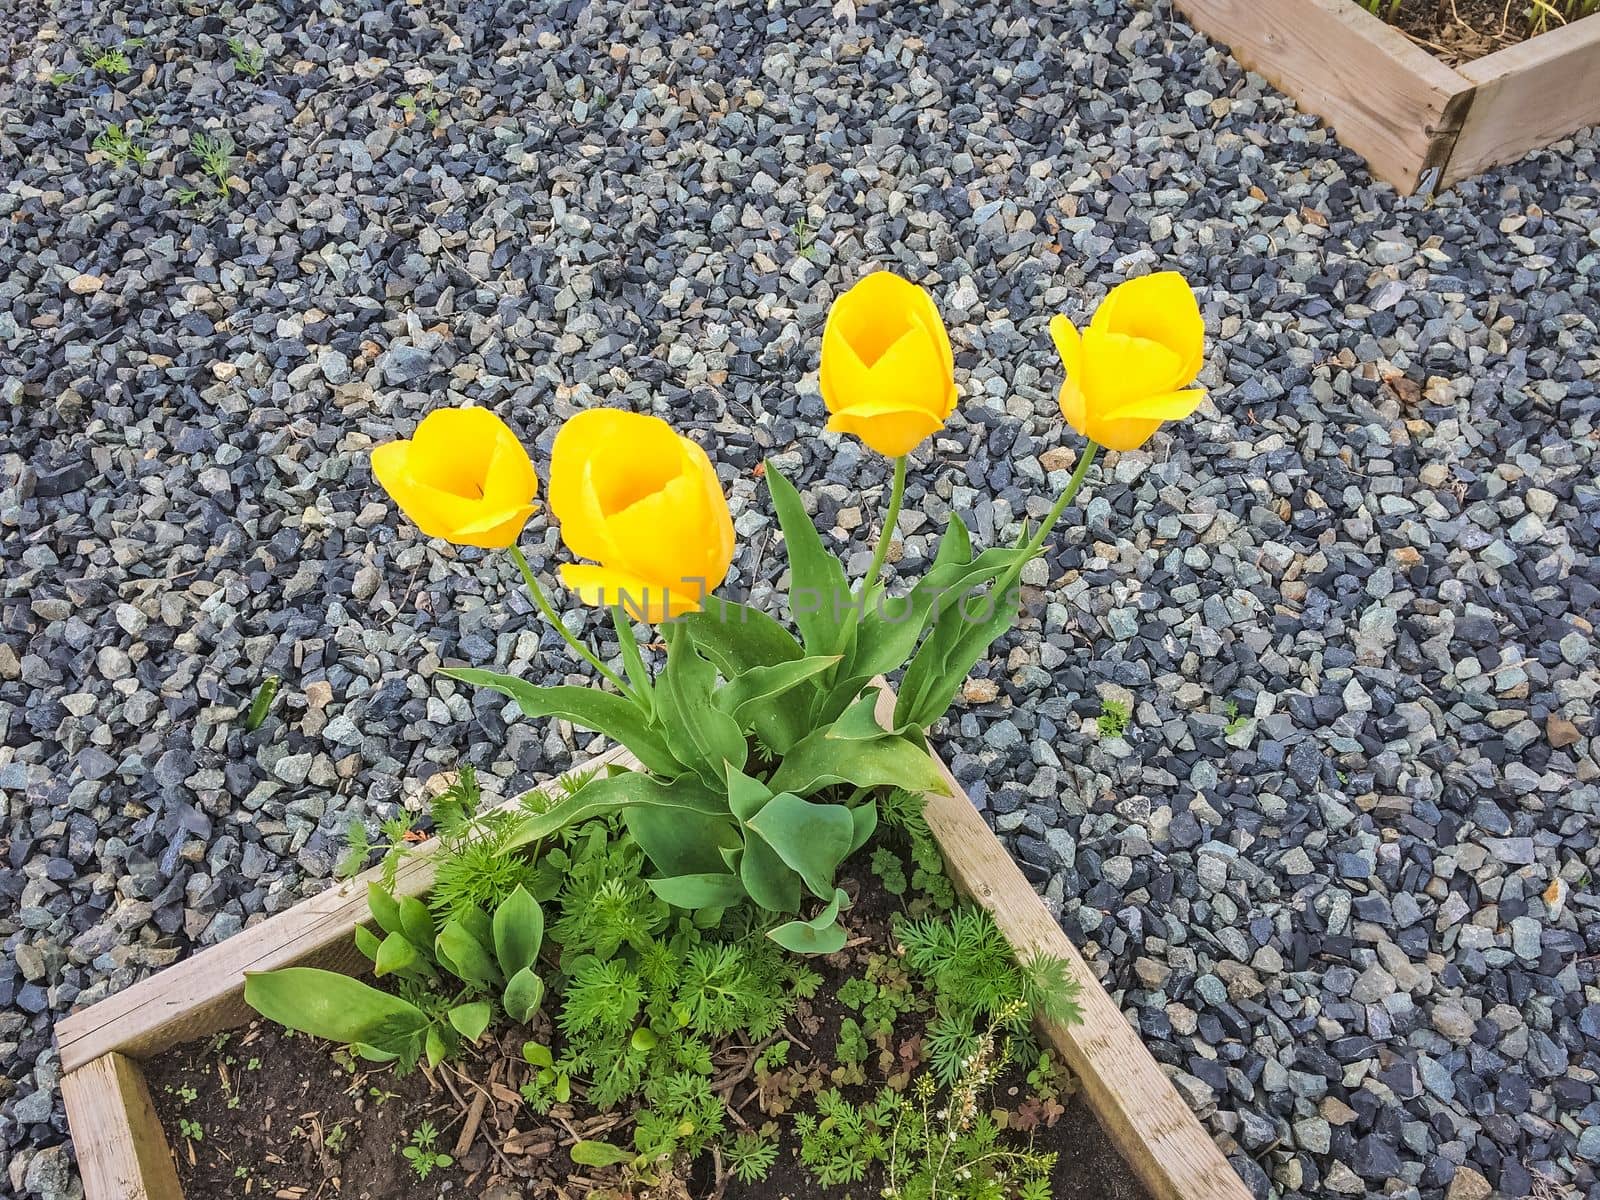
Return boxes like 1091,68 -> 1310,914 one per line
61,272 -> 1242,1200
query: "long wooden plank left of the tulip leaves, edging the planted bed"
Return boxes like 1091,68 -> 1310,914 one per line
56,747 -> 634,1070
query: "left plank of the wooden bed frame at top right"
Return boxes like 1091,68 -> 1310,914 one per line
1176,0 -> 1472,194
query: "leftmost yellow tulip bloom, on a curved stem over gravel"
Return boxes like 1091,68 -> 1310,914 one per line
373,408 -> 539,549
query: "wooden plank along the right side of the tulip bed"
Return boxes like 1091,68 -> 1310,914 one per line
877,688 -> 1250,1200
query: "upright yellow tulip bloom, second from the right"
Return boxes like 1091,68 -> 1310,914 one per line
818,270 -> 957,458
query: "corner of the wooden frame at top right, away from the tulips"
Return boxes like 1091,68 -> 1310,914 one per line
1174,0 -> 1600,195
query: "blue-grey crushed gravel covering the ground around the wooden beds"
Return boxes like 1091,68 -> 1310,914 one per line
0,0 -> 1600,1200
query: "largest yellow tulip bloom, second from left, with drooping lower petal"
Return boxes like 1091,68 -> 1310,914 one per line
550,408 -> 733,624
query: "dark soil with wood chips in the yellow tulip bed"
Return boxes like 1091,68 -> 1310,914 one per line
147,875 -> 1147,1200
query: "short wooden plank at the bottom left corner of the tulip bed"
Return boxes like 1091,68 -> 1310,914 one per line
61,1054 -> 184,1200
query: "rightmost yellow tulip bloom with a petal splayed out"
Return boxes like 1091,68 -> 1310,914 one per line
1050,270 -> 1205,450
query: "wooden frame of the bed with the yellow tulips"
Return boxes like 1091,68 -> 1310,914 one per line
56,732 -> 1250,1200
